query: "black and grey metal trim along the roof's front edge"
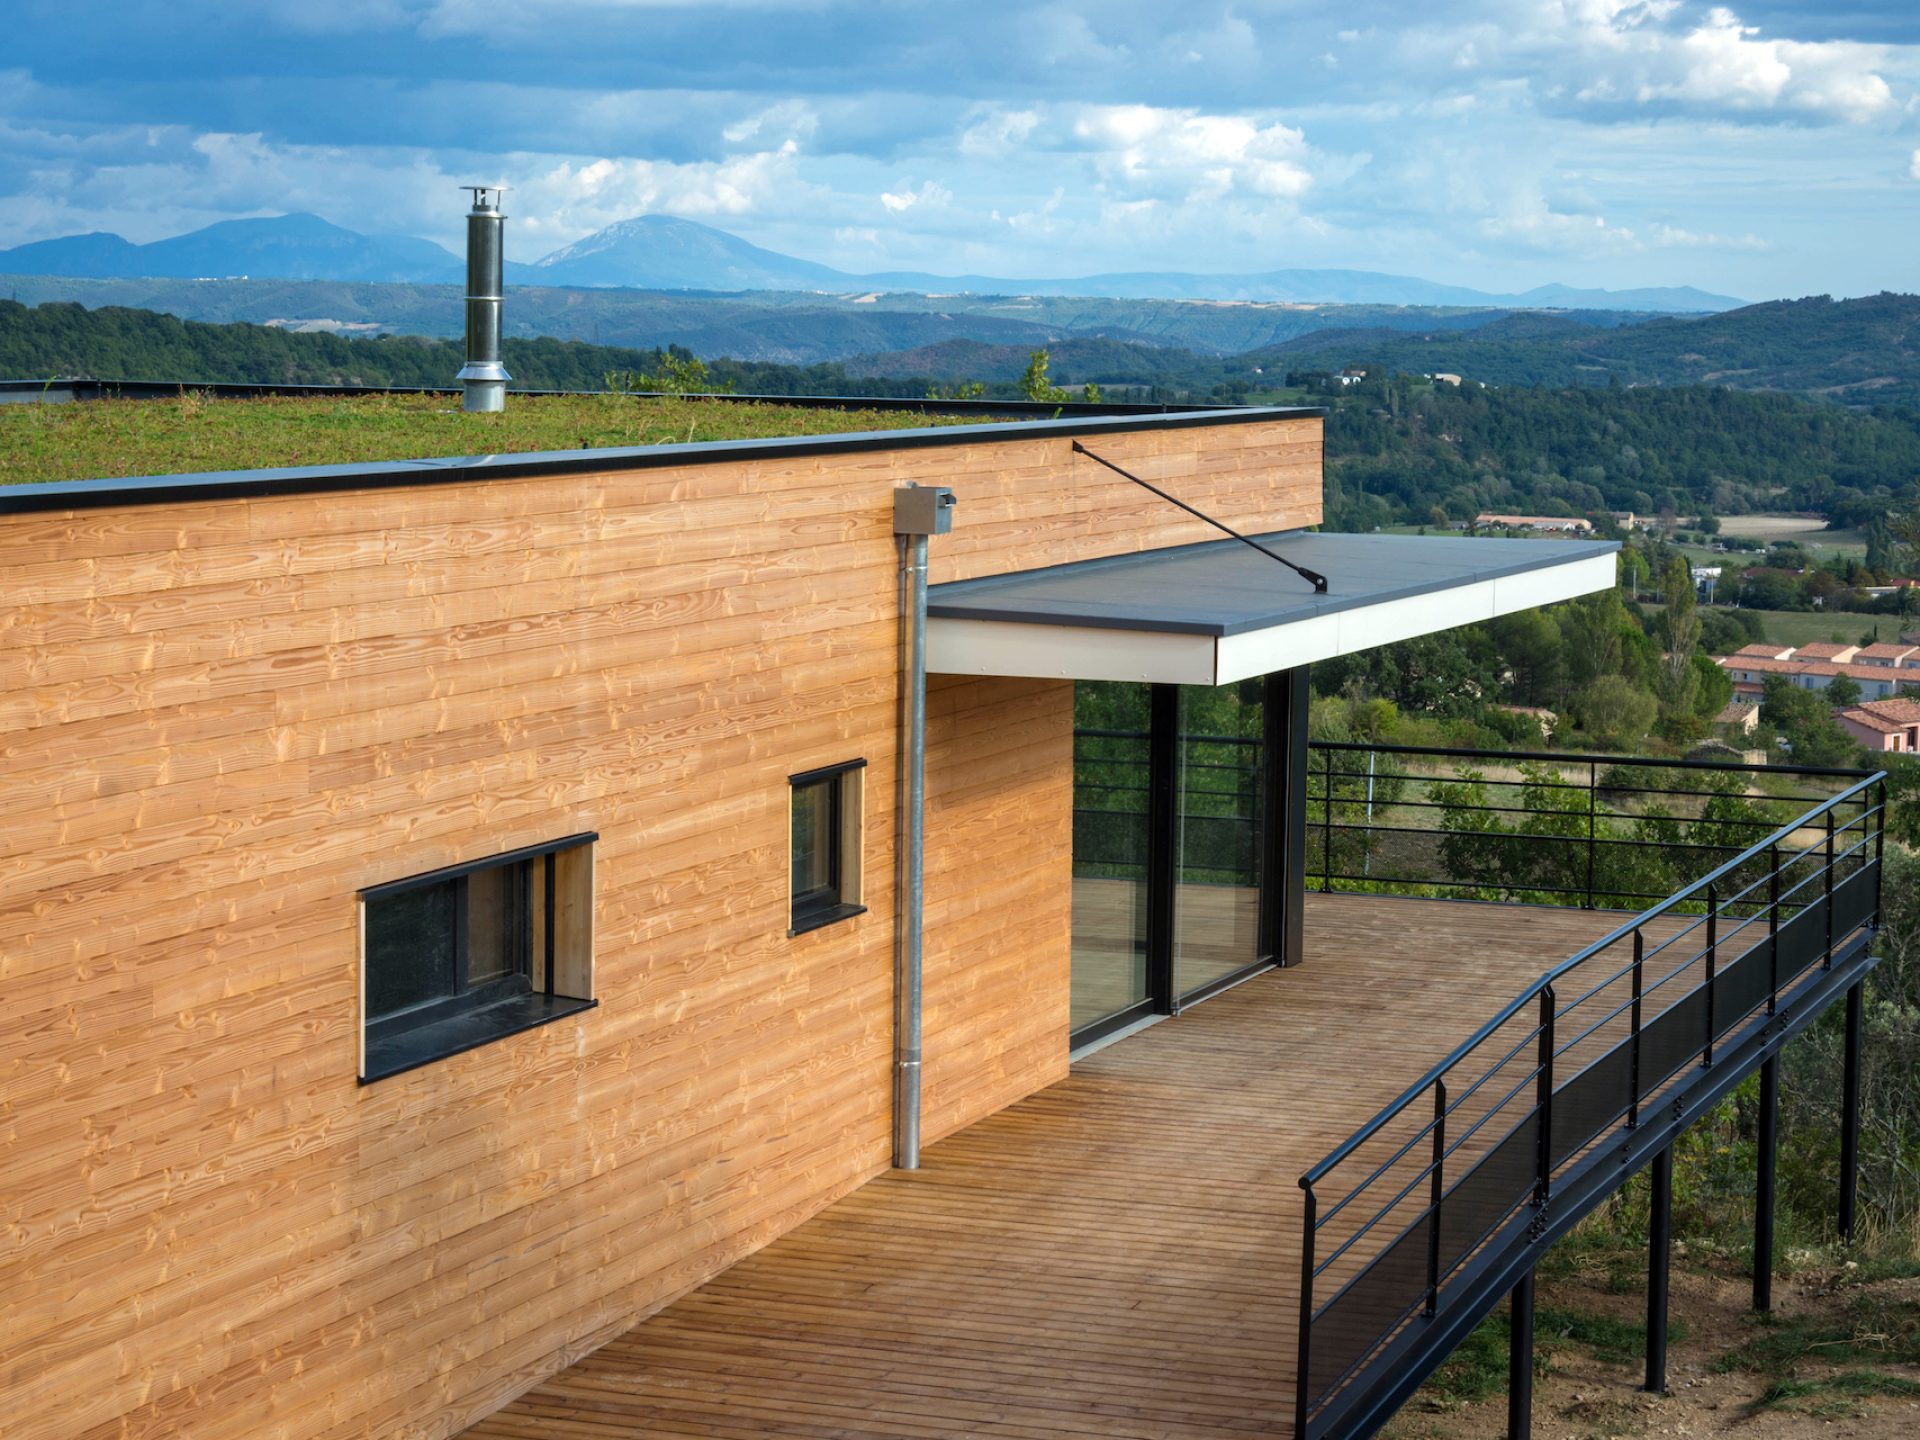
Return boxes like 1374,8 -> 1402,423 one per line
0,405 -> 1327,515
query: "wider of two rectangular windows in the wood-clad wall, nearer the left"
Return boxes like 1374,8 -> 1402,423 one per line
361,835 -> 599,1081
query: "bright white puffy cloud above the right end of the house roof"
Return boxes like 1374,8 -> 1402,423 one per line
1073,106 -> 1313,200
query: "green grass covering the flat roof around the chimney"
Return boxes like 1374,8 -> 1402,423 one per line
0,392 -> 990,486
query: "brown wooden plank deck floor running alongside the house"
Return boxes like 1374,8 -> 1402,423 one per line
467,895 -> 1651,1440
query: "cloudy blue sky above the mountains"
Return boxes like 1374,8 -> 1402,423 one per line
0,0 -> 1920,300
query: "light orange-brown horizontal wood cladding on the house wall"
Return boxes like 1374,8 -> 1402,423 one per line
0,419 -> 1319,1440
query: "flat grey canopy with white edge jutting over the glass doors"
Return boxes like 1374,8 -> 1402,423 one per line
927,532 -> 1619,685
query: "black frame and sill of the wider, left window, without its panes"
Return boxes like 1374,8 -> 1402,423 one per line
359,831 -> 599,1085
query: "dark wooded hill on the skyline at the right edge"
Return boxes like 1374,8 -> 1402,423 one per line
1240,294 -> 1920,405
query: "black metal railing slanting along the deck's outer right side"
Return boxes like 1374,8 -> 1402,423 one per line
1296,771 -> 1885,1440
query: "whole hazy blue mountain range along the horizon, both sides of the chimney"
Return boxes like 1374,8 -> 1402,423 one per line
0,215 -> 1745,313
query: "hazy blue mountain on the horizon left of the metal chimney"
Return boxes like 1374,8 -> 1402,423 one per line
0,215 -> 461,282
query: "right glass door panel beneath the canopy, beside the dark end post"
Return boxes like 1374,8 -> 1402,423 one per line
1173,680 -> 1265,996
